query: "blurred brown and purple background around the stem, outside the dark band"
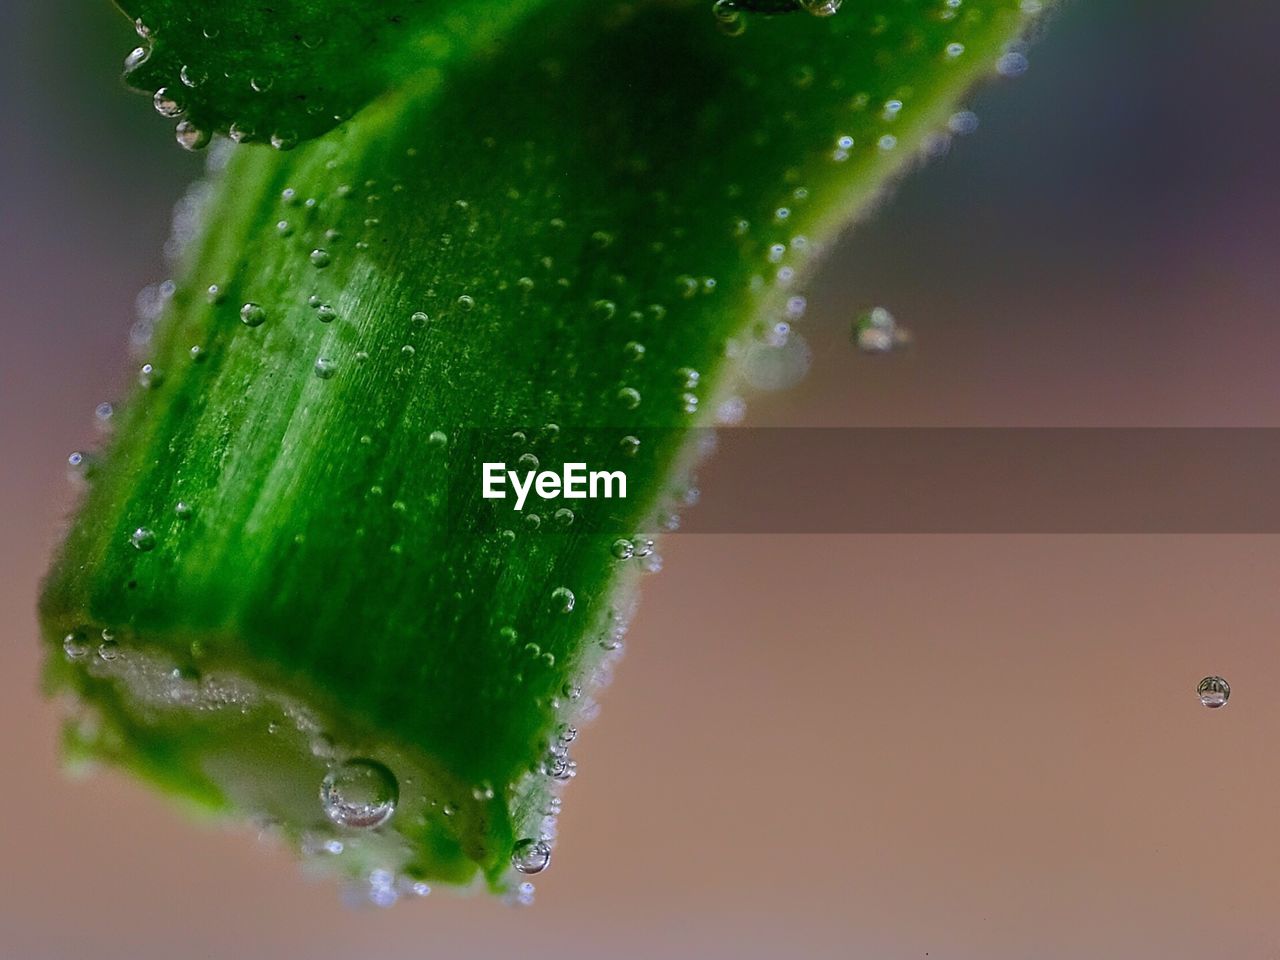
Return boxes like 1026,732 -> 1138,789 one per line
0,0 -> 1280,960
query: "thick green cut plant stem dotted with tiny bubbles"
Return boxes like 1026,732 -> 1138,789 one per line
44,0 -> 1049,896
